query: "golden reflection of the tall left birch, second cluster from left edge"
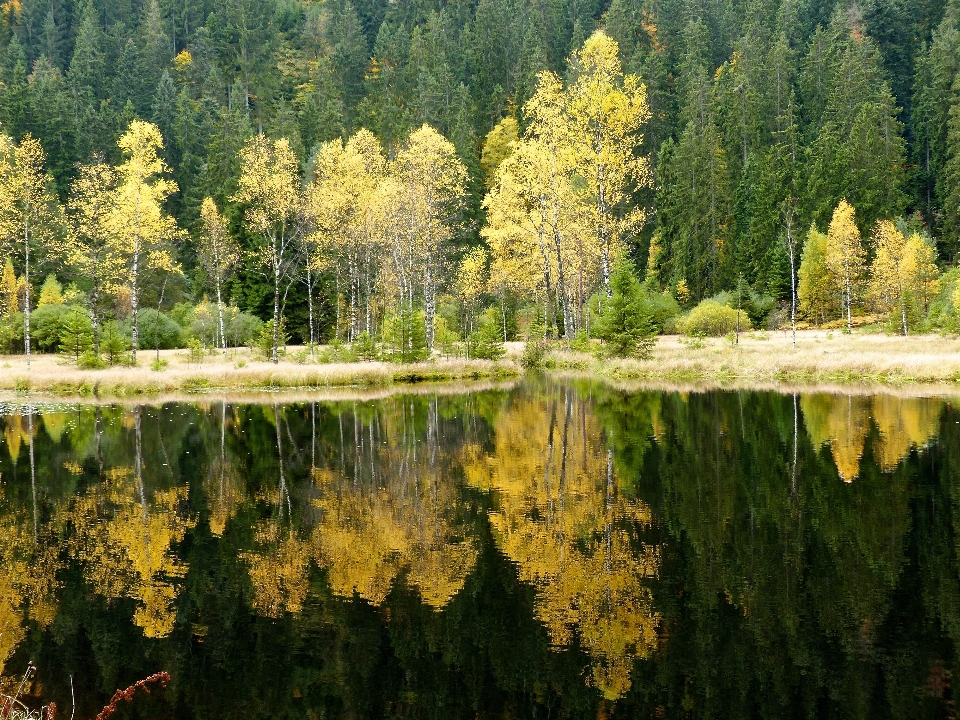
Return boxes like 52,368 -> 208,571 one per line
73,468 -> 194,637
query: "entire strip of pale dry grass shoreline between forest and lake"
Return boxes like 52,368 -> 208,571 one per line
0,330 -> 960,402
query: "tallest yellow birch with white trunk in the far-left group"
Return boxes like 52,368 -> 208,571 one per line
110,120 -> 182,363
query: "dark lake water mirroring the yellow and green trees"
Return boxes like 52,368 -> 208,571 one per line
0,380 -> 960,720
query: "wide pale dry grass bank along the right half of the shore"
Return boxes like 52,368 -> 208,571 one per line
549,330 -> 960,386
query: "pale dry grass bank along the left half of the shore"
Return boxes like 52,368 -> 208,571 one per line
0,350 -> 519,398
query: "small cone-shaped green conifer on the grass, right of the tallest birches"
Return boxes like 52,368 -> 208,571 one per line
596,260 -> 657,358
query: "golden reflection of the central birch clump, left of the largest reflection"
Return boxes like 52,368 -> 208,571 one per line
313,400 -> 477,609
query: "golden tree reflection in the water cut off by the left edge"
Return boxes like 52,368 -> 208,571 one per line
0,488 -> 60,676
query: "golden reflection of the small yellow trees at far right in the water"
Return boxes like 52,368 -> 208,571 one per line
800,394 -> 942,482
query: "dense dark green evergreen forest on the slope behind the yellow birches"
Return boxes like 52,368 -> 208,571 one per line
0,0 -> 960,344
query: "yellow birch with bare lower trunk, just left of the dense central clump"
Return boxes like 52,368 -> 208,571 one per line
233,134 -> 308,363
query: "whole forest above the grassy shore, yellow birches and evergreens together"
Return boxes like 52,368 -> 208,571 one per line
0,0 -> 960,360
